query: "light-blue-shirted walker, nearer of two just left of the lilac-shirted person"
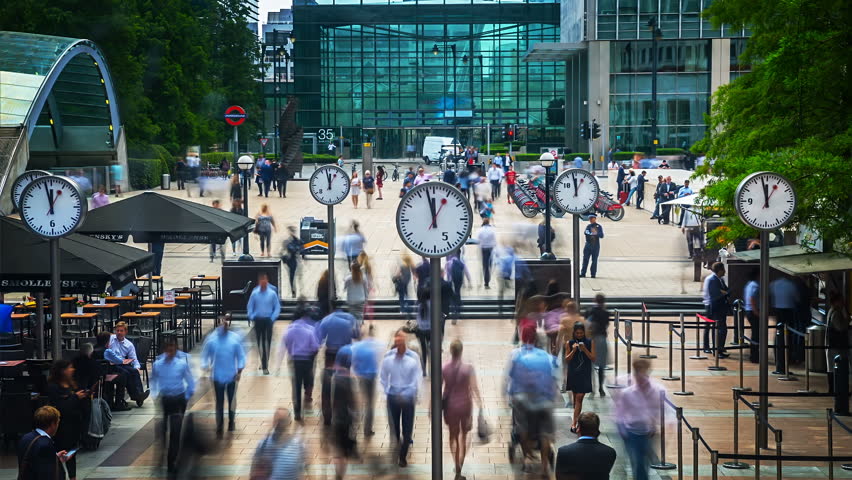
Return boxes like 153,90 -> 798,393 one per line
201,322 -> 246,438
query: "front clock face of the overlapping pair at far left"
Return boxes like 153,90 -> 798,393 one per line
20,175 -> 89,238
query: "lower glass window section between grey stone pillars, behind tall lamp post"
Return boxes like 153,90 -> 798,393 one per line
609,40 -> 711,150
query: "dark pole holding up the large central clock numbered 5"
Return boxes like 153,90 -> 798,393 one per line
430,258 -> 444,480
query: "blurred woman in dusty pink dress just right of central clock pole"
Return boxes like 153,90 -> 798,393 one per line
441,339 -> 482,480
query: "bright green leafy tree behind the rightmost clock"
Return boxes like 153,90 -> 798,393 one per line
693,0 -> 852,252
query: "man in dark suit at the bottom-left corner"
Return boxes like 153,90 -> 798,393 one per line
18,406 -> 69,480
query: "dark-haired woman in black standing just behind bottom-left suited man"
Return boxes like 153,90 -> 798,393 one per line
47,360 -> 91,480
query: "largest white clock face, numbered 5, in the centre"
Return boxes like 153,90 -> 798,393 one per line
396,182 -> 473,258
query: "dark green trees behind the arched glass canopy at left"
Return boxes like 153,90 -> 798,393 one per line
0,0 -> 262,152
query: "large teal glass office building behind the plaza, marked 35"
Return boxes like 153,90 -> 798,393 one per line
293,0 -> 565,158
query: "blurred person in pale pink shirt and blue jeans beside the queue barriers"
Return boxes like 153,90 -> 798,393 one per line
613,358 -> 665,480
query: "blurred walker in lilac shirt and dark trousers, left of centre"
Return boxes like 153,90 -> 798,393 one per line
278,298 -> 319,422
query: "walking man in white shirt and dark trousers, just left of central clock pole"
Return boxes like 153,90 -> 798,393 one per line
380,329 -> 420,468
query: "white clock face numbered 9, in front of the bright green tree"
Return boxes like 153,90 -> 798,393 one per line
734,172 -> 796,230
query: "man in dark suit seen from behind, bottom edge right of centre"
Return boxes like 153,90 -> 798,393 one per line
556,412 -> 616,480
